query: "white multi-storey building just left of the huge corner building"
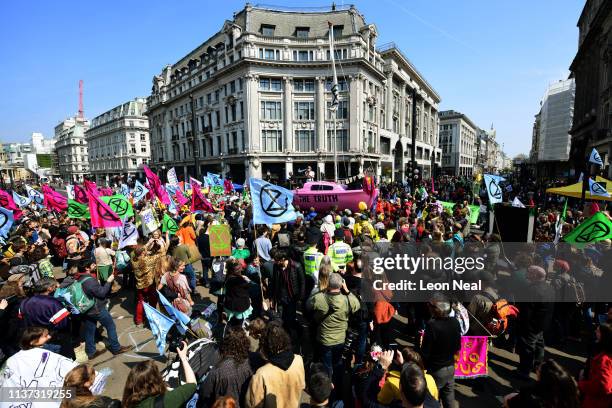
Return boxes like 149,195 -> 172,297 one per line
85,98 -> 151,184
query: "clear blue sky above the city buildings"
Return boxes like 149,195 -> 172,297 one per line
0,0 -> 585,157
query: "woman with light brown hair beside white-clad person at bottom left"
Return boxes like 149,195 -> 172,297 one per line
60,364 -> 121,408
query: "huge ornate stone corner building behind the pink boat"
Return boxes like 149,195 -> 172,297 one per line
147,5 -> 441,181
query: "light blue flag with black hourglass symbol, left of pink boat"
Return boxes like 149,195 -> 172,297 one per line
249,178 -> 297,224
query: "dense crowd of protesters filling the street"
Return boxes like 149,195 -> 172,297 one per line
0,173 -> 612,408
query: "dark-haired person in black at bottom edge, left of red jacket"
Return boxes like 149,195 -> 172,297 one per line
504,360 -> 580,408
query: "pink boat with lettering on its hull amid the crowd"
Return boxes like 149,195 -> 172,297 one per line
293,181 -> 378,211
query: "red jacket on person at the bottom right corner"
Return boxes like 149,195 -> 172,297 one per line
578,353 -> 612,408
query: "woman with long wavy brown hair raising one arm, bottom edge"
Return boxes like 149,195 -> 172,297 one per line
122,342 -> 197,408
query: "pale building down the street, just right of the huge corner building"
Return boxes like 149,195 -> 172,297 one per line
440,110 -> 478,176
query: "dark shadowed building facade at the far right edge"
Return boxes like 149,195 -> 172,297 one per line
570,0 -> 612,177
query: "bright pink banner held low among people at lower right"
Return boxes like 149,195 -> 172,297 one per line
455,336 -> 489,378
